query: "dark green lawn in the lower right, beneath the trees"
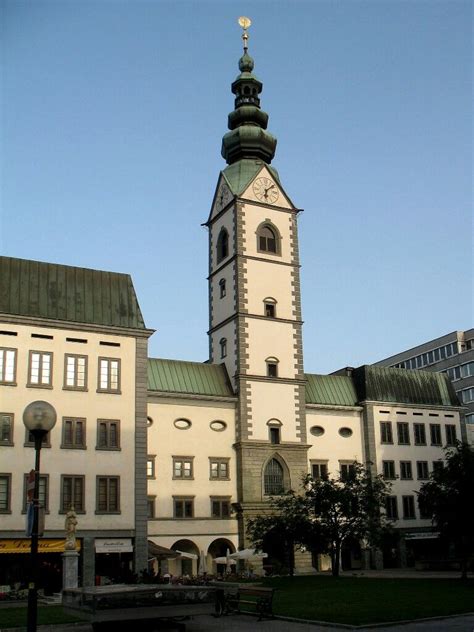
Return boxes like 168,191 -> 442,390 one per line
263,577 -> 474,625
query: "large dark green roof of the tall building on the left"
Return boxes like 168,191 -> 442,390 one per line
0,257 -> 145,329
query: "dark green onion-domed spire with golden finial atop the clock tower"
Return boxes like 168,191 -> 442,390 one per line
221,17 -> 277,165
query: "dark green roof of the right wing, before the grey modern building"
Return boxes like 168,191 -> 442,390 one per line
352,365 -> 459,406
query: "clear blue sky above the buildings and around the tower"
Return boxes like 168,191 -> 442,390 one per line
0,0 -> 473,373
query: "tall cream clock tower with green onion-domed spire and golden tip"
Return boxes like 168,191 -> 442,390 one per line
206,18 -> 309,545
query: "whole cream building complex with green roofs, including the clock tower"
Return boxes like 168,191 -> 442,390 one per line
0,25 -> 465,584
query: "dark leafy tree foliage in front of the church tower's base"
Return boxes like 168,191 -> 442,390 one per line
247,462 -> 390,576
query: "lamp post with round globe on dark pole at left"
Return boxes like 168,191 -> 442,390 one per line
23,401 -> 56,632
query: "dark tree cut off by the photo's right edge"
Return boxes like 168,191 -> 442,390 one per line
418,442 -> 474,579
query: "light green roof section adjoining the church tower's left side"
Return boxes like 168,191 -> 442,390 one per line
148,358 -> 234,397
